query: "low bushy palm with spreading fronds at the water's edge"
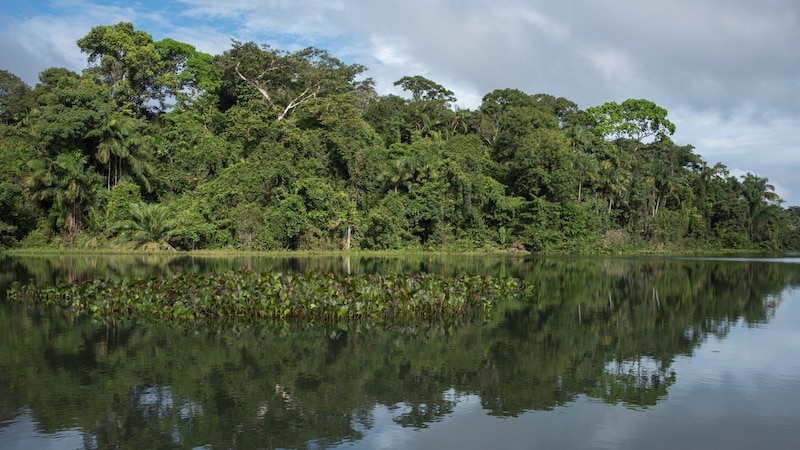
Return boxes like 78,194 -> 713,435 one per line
111,202 -> 178,251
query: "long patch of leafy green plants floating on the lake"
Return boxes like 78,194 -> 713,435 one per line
7,271 -> 522,329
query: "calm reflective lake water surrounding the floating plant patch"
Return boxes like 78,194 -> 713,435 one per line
0,256 -> 800,449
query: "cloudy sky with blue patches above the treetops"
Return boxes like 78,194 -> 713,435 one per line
0,0 -> 800,206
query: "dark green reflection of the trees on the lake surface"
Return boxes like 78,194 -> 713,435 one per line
0,258 -> 799,448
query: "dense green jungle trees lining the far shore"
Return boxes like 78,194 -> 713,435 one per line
0,23 -> 800,253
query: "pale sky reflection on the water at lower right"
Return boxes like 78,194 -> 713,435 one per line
342,289 -> 800,450
